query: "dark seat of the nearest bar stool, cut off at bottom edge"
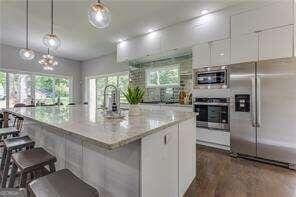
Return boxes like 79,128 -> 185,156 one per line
28,169 -> 99,197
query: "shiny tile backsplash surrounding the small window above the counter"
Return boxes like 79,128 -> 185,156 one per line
130,54 -> 192,103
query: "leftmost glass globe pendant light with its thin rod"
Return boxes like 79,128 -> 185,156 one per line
19,0 -> 35,60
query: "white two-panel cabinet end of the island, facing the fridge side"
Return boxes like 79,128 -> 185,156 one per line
141,119 -> 196,197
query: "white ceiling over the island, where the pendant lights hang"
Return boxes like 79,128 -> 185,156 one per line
0,0 -> 235,61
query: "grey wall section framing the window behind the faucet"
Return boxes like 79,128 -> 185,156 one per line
81,53 -> 129,99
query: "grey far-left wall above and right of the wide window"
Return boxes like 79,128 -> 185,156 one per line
0,44 -> 82,103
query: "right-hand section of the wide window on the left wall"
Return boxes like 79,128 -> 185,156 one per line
35,75 -> 70,105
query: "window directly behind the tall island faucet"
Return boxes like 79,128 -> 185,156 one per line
87,73 -> 129,107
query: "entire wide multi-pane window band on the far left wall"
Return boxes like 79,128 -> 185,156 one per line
0,71 -> 71,108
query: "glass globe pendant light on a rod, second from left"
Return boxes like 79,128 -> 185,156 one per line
43,0 -> 61,50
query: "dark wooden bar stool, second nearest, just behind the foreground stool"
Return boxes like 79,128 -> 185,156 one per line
8,147 -> 57,188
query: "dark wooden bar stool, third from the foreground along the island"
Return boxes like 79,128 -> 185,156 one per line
0,136 -> 35,188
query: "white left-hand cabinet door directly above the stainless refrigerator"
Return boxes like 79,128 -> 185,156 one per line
231,33 -> 258,64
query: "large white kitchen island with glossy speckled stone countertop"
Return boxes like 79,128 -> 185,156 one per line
5,105 -> 196,197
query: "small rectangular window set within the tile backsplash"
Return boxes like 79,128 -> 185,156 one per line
145,64 -> 180,87
